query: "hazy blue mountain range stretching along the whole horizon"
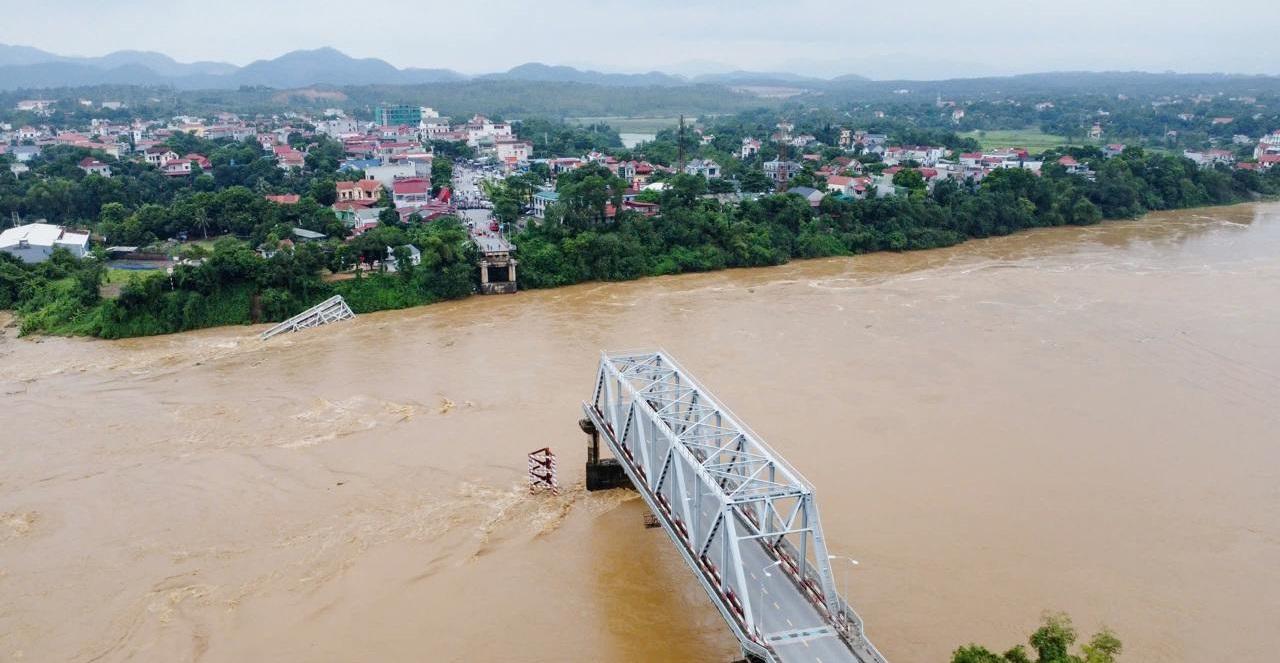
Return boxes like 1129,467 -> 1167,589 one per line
0,44 -> 1280,96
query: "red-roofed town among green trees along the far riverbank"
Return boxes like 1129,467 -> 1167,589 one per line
0,85 -> 1280,334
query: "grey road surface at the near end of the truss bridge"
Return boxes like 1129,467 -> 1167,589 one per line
677,495 -> 870,663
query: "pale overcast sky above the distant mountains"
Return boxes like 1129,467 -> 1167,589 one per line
0,0 -> 1280,79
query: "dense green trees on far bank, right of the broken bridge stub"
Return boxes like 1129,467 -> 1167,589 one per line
515,148 -> 1280,288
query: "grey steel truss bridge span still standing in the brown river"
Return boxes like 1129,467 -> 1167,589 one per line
582,351 -> 886,663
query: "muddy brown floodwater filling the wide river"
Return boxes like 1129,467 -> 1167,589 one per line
0,204 -> 1280,663
